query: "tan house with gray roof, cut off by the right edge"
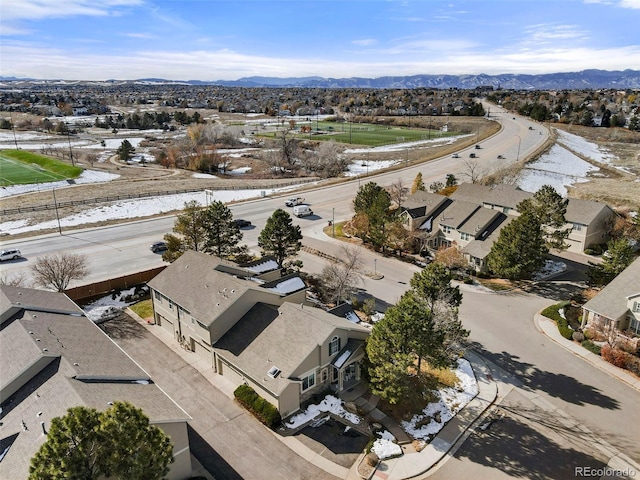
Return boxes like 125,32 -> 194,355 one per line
582,257 -> 640,347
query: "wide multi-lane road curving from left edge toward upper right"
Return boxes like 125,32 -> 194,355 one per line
0,106 -> 548,287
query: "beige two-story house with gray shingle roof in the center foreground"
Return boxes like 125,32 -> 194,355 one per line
149,251 -> 369,417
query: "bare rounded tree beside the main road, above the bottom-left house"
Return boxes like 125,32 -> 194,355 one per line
31,252 -> 89,292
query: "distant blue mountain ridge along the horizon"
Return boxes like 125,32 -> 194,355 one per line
0,69 -> 640,90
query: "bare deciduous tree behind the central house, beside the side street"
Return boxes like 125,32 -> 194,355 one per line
321,245 -> 362,305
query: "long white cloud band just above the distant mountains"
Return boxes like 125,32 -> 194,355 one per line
2,42 -> 640,80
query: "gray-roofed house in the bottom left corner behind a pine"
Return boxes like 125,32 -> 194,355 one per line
0,285 -> 192,480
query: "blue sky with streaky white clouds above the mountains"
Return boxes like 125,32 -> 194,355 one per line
0,0 -> 640,80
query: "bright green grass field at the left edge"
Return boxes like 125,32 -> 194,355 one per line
0,150 -> 82,186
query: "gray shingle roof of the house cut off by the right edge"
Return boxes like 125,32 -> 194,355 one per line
583,257 -> 640,320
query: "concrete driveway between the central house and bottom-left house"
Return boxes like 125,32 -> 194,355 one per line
102,315 -> 336,480
